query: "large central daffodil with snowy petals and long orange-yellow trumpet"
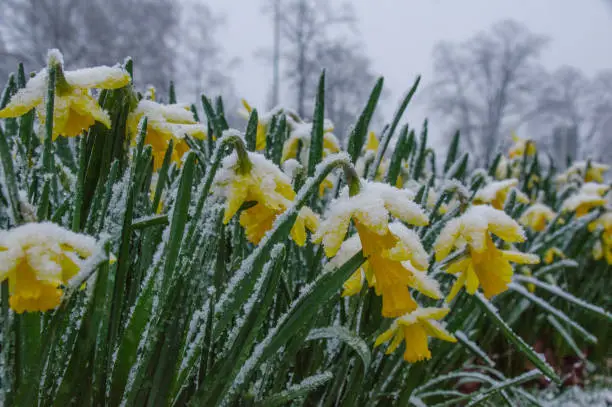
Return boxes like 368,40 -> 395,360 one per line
313,182 -> 430,317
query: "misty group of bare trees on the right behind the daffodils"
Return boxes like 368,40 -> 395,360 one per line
427,21 -> 612,167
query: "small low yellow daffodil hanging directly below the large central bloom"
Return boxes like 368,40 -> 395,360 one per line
374,307 -> 457,363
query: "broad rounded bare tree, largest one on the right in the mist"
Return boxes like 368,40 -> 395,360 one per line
429,21 -> 547,162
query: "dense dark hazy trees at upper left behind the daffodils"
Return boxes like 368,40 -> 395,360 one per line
0,0 -> 238,108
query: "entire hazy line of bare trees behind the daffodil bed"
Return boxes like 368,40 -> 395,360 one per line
0,0 -> 612,163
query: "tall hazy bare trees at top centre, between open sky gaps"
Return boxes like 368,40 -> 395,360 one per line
264,0 -> 384,138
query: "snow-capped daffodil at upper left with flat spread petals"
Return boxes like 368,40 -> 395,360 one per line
0,50 -> 131,140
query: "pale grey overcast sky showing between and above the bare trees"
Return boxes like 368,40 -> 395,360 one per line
208,0 -> 612,135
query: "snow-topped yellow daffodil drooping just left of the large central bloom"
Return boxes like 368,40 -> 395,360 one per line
215,152 -> 319,246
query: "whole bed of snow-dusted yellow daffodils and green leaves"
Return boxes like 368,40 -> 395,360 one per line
0,52 -> 612,407
